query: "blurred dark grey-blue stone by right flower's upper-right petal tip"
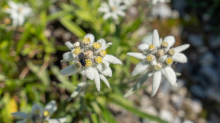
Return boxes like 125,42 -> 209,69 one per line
188,34 -> 203,47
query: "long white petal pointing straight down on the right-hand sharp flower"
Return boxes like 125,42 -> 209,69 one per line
151,70 -> 162,97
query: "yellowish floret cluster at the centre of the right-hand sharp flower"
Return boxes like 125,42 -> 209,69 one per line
147,42 -> 175,70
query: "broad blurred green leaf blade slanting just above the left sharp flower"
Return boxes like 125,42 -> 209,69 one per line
60,17 -> 86,38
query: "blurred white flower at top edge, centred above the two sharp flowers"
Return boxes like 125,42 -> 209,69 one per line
98,0 -> 126,21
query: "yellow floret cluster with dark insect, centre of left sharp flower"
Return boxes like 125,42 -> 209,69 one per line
72,37 -> 106,69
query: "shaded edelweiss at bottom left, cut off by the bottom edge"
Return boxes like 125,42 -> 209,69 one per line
12,100 -> 66,123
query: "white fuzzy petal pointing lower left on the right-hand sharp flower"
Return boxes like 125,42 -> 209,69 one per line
131,61 -> 149,77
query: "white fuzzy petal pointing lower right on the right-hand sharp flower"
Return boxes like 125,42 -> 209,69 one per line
162,66 -> 176,86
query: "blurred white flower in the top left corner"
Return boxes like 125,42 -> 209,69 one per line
5,1 -> 31,26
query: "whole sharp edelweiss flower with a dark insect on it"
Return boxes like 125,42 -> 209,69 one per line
60,34 -> 121,91
